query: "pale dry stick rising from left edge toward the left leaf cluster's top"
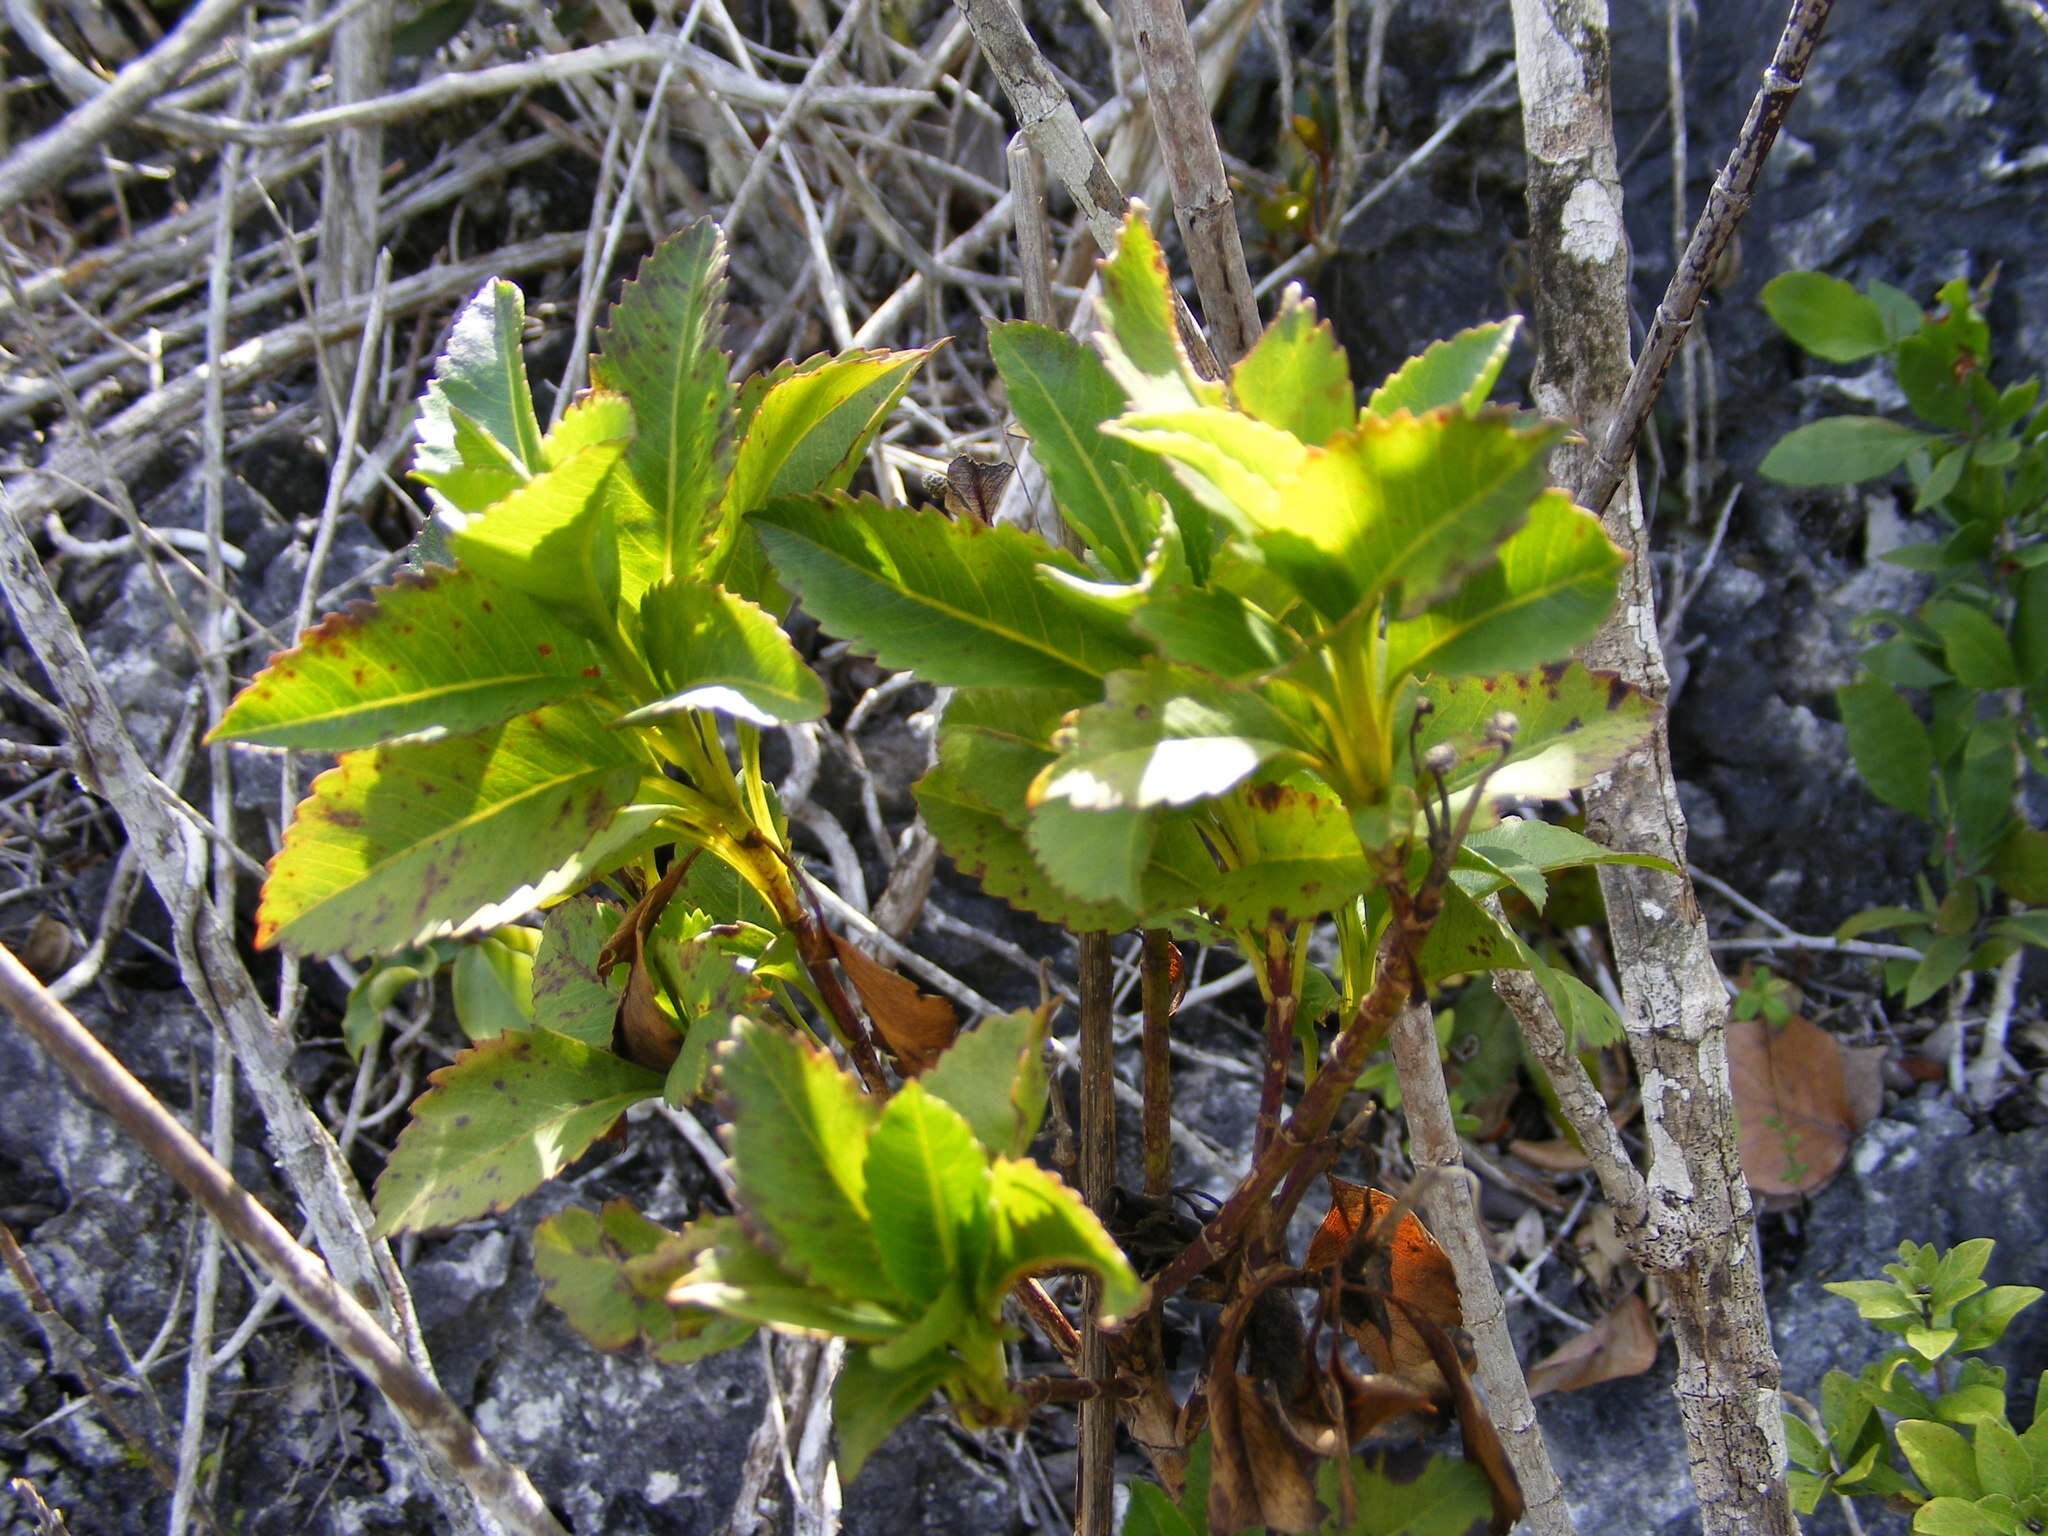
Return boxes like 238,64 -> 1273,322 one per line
12,231 -> 584,518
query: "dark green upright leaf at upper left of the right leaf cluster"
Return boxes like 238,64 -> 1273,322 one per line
989,319 -> 1171,582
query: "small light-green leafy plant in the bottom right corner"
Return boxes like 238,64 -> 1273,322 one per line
1786,1237 -> 2048,1536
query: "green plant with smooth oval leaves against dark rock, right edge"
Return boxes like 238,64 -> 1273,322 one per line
1763,272 -> 2048,1006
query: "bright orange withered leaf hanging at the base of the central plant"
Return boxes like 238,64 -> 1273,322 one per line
1305,1174 -> 1464,1391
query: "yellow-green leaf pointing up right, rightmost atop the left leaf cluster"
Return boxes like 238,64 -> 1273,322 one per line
721,346 -> 936,520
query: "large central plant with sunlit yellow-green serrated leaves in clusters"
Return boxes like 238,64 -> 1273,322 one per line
215,207 -> 1655,1528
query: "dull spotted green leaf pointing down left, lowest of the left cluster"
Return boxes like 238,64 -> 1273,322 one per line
375,1030 -> 662,1235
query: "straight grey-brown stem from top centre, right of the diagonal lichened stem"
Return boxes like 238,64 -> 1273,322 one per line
1130,0 -> 1261,367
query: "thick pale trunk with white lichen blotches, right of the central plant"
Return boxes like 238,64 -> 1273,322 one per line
1513,0 -> 1802,1536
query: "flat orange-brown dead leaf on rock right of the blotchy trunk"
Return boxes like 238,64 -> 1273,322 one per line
1729,1014 -> 1855,1194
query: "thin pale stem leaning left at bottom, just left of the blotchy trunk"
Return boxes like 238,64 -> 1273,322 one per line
1389,1004 -> 1573,1536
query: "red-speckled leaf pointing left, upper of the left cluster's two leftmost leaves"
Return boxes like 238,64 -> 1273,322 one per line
207,567 -> 604,752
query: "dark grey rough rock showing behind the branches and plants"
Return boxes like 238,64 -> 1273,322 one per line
0,0 -> 2048,1536
